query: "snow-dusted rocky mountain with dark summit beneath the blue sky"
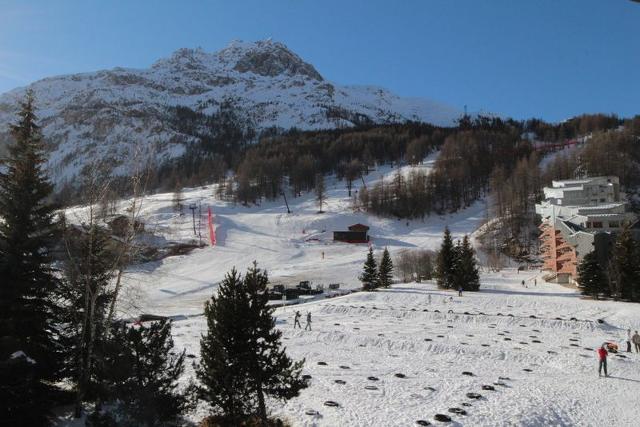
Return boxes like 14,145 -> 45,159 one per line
0,40 -> 460,184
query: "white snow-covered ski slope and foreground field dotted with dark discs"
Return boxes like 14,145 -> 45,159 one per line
61,161 -> 640,427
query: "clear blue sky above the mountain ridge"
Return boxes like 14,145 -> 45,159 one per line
0,0 -> 640,121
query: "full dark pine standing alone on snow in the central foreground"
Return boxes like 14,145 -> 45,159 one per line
196,264 -> 307,425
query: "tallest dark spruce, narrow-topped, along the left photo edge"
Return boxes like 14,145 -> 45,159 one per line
0,92 -> 61,425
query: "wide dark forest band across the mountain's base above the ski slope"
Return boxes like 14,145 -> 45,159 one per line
53,103 -> 632,222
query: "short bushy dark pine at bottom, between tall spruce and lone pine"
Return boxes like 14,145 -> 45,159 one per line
97,320 -> 192,427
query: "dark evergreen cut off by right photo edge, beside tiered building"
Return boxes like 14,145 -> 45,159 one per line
612,227 -> 640,301
